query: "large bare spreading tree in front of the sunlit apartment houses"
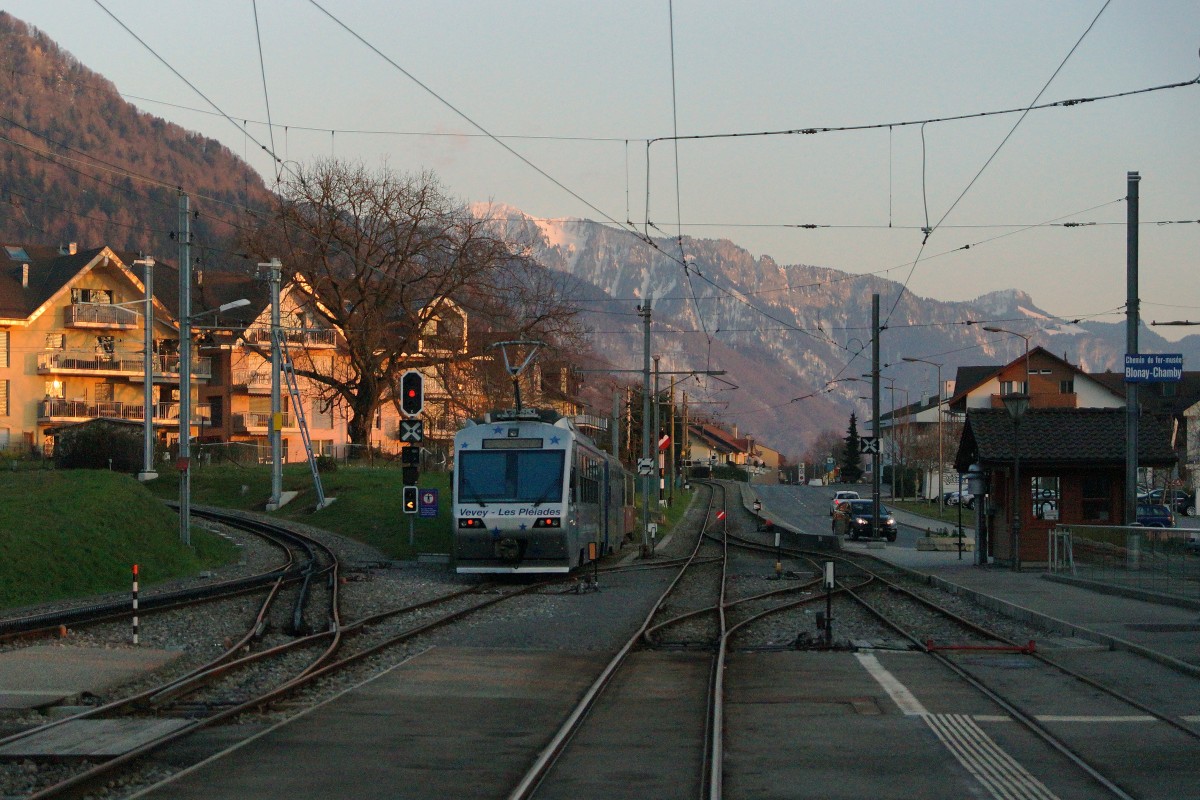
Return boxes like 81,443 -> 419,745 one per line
246,160 -> 576,445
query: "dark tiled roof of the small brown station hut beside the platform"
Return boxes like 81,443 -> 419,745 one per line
954,408 -> 1176,473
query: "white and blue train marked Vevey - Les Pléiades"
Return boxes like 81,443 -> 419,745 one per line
452,409 -> 634,573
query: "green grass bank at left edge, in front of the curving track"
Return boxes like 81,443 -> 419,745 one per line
0,470 -> 238,608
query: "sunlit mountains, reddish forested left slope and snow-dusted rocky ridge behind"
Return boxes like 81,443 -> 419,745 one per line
0,12 -> 1200,459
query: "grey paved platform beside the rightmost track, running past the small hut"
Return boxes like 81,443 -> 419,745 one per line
842,542 -> 1200,676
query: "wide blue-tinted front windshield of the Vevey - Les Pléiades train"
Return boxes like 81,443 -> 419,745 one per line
457,450 -> 565,504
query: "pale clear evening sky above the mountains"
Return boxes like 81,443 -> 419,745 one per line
2,0 -> 1200,339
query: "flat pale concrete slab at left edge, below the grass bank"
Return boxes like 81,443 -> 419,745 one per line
0,644 -> 180,709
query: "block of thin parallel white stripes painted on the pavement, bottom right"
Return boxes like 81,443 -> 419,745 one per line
924,714 -> 1058,800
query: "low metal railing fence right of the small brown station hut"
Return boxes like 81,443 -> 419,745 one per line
1050,525 -> 1200,599
